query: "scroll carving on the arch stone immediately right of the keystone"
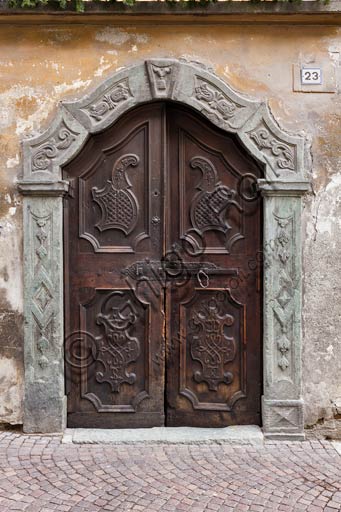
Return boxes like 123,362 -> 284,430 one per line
193,79 -> 244,122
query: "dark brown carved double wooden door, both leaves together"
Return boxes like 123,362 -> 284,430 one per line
64,103 -> 262,428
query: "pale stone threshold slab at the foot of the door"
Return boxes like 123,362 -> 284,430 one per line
62,425 -> 264,446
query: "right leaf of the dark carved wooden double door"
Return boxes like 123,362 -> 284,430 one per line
166,107 -> 261,427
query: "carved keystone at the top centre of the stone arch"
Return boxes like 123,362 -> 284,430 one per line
146,59 -> 177,98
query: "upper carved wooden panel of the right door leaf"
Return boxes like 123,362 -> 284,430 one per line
171,112 -> 259,254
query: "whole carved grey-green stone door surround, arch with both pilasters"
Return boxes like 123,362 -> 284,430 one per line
18,59 -> 309,438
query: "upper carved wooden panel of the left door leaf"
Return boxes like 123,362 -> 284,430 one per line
79,121 -> 151,253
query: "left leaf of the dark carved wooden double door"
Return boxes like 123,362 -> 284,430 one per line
64,104 -> 165,428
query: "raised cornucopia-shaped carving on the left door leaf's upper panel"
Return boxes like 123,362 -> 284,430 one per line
92,154 -> 139,235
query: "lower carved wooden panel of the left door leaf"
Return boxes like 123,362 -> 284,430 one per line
79,289 -> 150,412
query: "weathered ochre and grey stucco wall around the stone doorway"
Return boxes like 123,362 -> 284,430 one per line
0,23 -> 341,425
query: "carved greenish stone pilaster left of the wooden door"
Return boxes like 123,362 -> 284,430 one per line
21,183 -> 66,432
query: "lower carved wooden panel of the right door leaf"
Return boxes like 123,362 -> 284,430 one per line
180,288 -> 245,410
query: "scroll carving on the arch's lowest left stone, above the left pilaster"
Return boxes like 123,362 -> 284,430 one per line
32,122 -> 79,172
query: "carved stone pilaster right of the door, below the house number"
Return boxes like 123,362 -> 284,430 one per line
259,180 -> 307,439
